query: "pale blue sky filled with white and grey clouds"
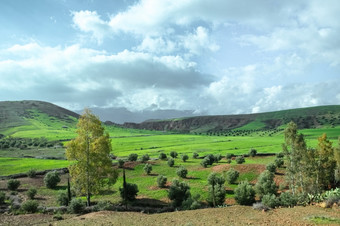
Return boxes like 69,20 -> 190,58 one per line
0,0 -> 340,114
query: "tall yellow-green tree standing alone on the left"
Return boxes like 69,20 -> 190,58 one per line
66,109 -> 118,206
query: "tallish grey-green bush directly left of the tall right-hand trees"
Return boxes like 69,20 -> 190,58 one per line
255,170 -> 277,198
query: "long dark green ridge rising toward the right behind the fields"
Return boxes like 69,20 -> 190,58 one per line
123,105 -> 340,133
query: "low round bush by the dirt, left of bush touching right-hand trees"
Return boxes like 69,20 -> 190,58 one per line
234,181 -> 255,205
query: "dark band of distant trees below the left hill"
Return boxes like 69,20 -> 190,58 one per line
0,135 -> 63,149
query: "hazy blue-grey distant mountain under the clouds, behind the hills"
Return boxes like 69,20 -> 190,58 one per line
76,108 -> 197,124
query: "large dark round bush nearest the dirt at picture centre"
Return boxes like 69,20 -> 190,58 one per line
168,179 -> 191,207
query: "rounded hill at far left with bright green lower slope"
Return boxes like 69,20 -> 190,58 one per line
0,100 -> 79,138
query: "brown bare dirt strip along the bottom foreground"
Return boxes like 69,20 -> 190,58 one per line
0,205 -> 340,225
